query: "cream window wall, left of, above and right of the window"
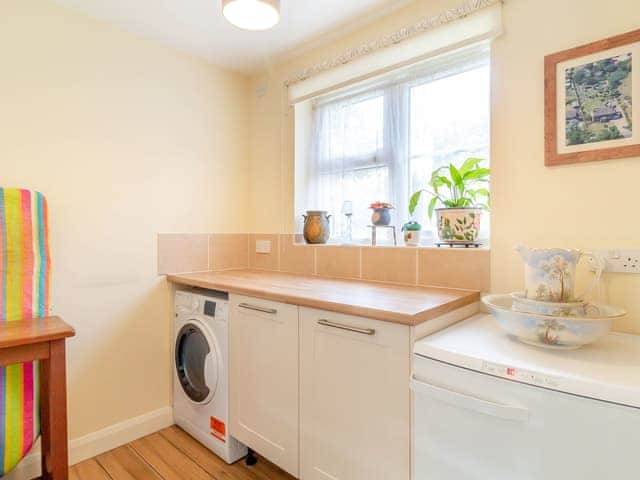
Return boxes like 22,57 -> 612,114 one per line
250,0 -> 640,333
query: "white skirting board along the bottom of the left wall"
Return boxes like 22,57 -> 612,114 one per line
3,407 -> 173,480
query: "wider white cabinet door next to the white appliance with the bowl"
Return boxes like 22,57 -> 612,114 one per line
300,308 -> 410,480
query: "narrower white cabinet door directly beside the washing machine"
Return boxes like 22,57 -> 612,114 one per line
229,295 -> 299,477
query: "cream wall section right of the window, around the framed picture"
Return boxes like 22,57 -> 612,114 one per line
491,0 -> 640,333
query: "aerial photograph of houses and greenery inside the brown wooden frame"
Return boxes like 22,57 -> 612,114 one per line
564,52 -> 633,146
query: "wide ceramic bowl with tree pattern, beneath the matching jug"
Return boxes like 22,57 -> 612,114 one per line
482,295 -> 626,350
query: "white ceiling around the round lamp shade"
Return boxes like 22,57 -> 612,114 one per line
54,0 -> 408,73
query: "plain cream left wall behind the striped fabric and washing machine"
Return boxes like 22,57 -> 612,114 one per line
0,0 -> 248,438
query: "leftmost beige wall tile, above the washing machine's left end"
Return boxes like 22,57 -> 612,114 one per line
158,233 -> 209,275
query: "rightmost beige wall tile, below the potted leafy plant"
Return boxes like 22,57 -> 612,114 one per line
418,248 -> 491,292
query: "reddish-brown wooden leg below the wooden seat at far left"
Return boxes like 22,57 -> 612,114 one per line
40,340 -> 69,480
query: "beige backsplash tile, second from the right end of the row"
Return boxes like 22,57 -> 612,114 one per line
362,247 -> 418,285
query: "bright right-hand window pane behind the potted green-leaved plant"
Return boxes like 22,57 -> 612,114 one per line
409,66 -> 490,237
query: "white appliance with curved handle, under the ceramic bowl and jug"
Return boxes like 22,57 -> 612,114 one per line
411,314 -> 640,480
